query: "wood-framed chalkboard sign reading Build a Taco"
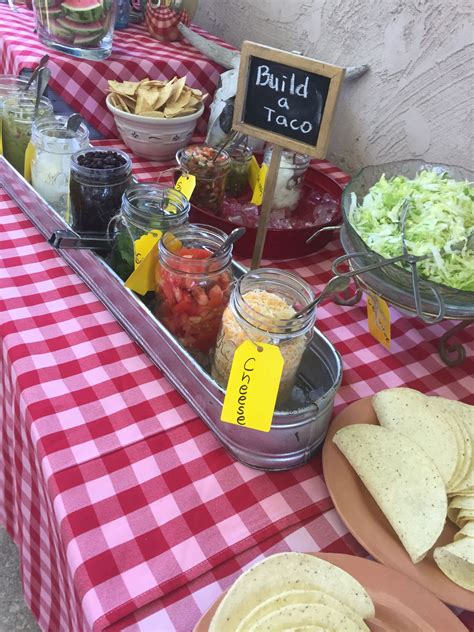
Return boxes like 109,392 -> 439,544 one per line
233,42 -> 344,158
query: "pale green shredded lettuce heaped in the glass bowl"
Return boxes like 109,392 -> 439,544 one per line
349,171 -> 474,292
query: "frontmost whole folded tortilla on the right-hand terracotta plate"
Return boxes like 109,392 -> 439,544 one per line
333,424 -> 447,564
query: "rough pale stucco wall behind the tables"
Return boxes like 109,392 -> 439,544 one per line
195,0 -> 474,172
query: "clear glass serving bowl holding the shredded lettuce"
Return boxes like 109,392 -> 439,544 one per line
341,160 -> 474,320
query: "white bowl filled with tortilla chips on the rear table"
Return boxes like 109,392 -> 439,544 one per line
106,77 -> 207,160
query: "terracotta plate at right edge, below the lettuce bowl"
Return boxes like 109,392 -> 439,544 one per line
323,397 -> 474,608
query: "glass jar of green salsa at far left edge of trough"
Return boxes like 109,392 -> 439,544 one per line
2,92 -> 53,175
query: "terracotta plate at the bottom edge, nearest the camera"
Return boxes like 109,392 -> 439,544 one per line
194,553 -> 467,632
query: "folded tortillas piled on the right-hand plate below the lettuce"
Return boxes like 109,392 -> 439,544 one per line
334,388 -> 474,590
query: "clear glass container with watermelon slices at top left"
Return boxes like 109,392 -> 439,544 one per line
33,0 -> 115,59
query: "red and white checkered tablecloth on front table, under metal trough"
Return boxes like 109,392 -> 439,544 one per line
0,141 -> 474,632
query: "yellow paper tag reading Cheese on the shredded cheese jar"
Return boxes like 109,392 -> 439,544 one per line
221,340 -> 283,432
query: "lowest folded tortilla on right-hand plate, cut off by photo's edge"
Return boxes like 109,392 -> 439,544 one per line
433,538 -> 474,591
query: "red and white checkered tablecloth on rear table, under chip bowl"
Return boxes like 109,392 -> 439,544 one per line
0,4 -> 230,137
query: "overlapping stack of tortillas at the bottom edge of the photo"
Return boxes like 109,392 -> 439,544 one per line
209,553 -> 375,632
